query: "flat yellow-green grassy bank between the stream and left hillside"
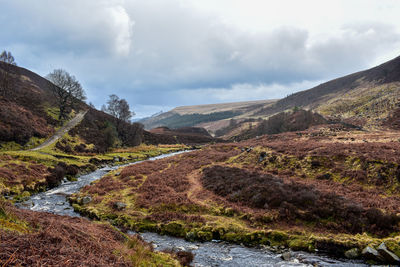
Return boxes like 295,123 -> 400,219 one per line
0,144 -> 187,200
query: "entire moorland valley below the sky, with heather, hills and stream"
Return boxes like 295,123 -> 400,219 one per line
0,55 -> 400,266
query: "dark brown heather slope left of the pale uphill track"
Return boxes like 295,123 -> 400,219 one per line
0,62 -> 57,148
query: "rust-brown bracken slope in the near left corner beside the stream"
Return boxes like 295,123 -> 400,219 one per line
0,200 -> 180,266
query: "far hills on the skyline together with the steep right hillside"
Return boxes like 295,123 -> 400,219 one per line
141,54 -> 400,138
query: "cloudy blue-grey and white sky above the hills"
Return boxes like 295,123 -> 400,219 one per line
0,0 -> 400,118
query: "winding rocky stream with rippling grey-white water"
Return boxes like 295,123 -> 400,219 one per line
18,151 -> 367,267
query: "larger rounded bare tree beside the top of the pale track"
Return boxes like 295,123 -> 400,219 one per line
46,69 -> 86,120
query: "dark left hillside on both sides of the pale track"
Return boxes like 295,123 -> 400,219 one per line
0,62 -> 217,153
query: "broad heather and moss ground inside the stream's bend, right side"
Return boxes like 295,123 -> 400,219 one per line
71,127 -> 400,263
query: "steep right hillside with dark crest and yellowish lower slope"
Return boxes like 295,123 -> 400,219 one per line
257,57 -> 400,127
